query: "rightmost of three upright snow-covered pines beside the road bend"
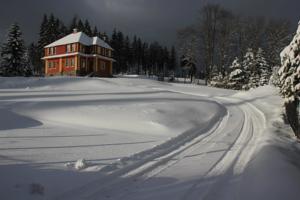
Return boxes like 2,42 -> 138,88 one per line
256,48 -> 271,86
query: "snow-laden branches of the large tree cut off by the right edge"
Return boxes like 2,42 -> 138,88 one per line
279,22 -> 300,102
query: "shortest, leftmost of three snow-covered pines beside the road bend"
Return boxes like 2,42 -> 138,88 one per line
228,58 -> 246,90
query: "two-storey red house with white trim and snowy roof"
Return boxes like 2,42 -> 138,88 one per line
42,30 -> 114,77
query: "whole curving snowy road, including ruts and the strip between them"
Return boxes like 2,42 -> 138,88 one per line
57,87 -> 266,200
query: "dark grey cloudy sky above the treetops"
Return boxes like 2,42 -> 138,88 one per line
0,0 -> 300,46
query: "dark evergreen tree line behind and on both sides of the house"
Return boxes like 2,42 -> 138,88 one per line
0,14 -> 177,76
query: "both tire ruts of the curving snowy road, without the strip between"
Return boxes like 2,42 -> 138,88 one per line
57,88 -> 266,200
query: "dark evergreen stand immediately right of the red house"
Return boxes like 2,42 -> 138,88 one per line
110,29 -> 177,76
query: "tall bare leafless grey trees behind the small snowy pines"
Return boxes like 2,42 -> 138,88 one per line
178,4 -> 291,83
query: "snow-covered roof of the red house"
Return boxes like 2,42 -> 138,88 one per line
45,32 -> 112,50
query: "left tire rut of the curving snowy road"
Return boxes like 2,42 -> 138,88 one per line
56,95 -> 228,199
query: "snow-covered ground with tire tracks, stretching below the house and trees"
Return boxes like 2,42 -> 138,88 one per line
0,77 -> 300,200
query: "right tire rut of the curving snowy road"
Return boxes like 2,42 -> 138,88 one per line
183,98 -> 266,200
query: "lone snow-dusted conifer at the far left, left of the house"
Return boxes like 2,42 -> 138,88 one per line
1,23 -> 25,76
